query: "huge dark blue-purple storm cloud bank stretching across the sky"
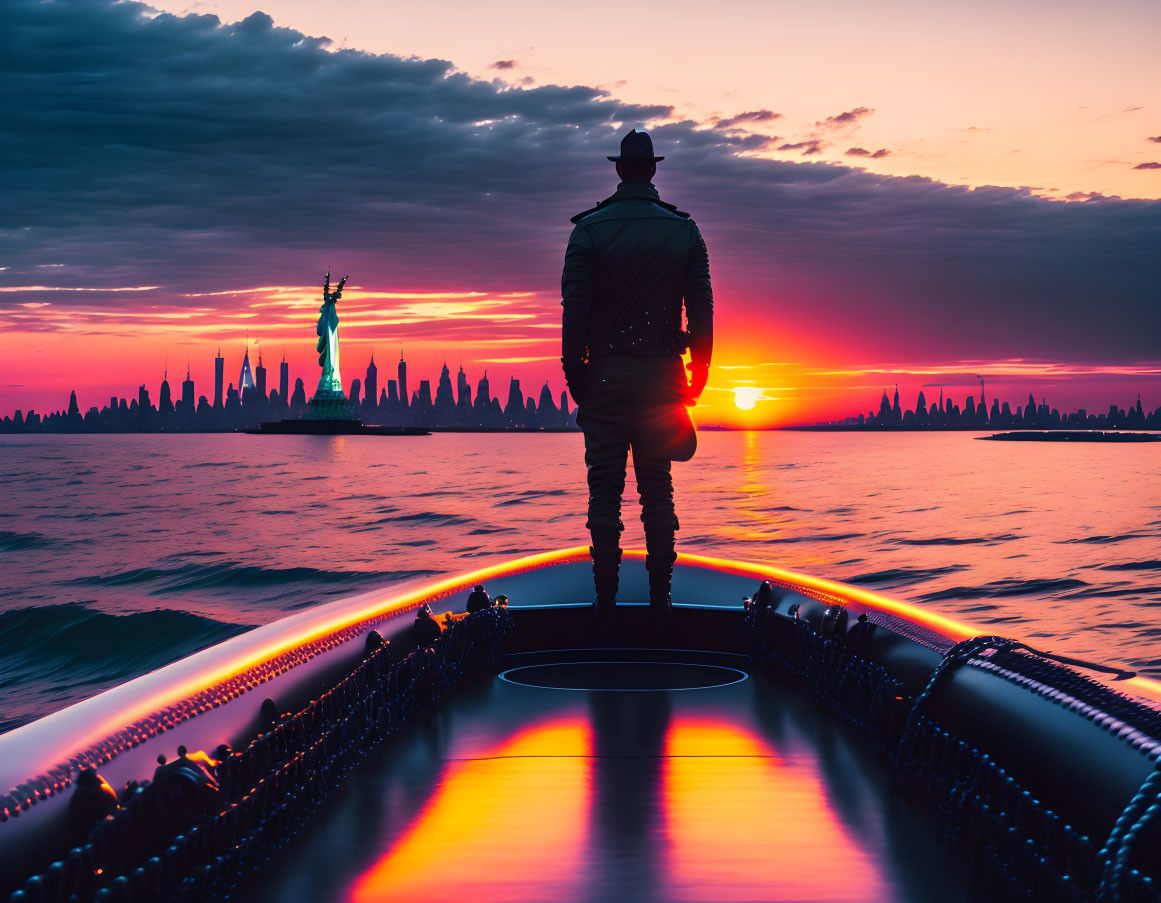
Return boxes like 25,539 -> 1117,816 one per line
0,0 -> 1161,360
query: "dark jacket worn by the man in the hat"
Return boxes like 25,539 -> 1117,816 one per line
561,182 -> 714,373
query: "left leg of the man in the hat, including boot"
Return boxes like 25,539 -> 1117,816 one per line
584,418 -> 629,615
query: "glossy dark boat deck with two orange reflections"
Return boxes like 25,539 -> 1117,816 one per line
249,650 -> 961,903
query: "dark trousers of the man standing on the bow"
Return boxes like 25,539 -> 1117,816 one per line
577,354 -> 686,533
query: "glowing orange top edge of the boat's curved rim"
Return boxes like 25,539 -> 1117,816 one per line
0,546 -> 1161,808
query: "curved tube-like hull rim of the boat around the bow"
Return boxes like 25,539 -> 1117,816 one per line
0,548 -> 1161,890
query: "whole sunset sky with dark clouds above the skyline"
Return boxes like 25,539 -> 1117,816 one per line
0,0 -> 1161,426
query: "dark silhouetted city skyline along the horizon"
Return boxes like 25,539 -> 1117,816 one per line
0,345 -> 1161,432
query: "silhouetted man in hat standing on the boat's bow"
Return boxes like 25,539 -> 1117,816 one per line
561,129 -> 714,620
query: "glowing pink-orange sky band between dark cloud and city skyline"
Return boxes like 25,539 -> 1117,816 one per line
0,280 -> 1161,428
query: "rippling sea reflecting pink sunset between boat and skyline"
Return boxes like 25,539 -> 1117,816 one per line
0,432 -> 1161,730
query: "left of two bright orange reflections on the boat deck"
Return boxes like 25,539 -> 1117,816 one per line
348,717 -> 592,903
